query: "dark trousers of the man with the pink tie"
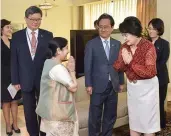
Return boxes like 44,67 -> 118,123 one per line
22,88 -> 45,136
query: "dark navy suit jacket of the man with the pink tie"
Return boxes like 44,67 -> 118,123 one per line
11,29 -> 53,92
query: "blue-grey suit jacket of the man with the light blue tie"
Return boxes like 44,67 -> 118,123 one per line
84,36 -> 124,93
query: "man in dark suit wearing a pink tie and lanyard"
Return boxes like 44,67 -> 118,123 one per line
11,6 -> 53,136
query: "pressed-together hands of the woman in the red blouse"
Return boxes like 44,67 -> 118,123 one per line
122,48 -> 132,64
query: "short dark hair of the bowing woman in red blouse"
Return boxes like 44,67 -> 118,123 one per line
119,16 -> 142,37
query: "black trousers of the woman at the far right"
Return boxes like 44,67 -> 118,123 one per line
159,84 -> 168,128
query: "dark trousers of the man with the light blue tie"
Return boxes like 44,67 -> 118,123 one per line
88,81 -> 118,136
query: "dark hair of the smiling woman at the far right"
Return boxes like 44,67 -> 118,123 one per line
148,18 -> 164,36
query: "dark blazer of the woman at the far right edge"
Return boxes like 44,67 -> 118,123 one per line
154,37 -> 170,85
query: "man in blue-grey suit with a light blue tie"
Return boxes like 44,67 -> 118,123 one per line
84,14 -> 124,136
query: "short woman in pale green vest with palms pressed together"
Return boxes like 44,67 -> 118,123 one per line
36,37 -> 78,136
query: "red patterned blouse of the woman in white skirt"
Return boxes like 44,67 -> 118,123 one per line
113,39 -> 157,81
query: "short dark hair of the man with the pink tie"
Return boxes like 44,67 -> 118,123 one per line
25,6 -> 42,18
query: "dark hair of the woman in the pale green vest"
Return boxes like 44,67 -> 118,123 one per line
48,37 -> 68,58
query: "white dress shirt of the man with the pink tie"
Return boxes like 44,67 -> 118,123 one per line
26,27 -> 39,60
